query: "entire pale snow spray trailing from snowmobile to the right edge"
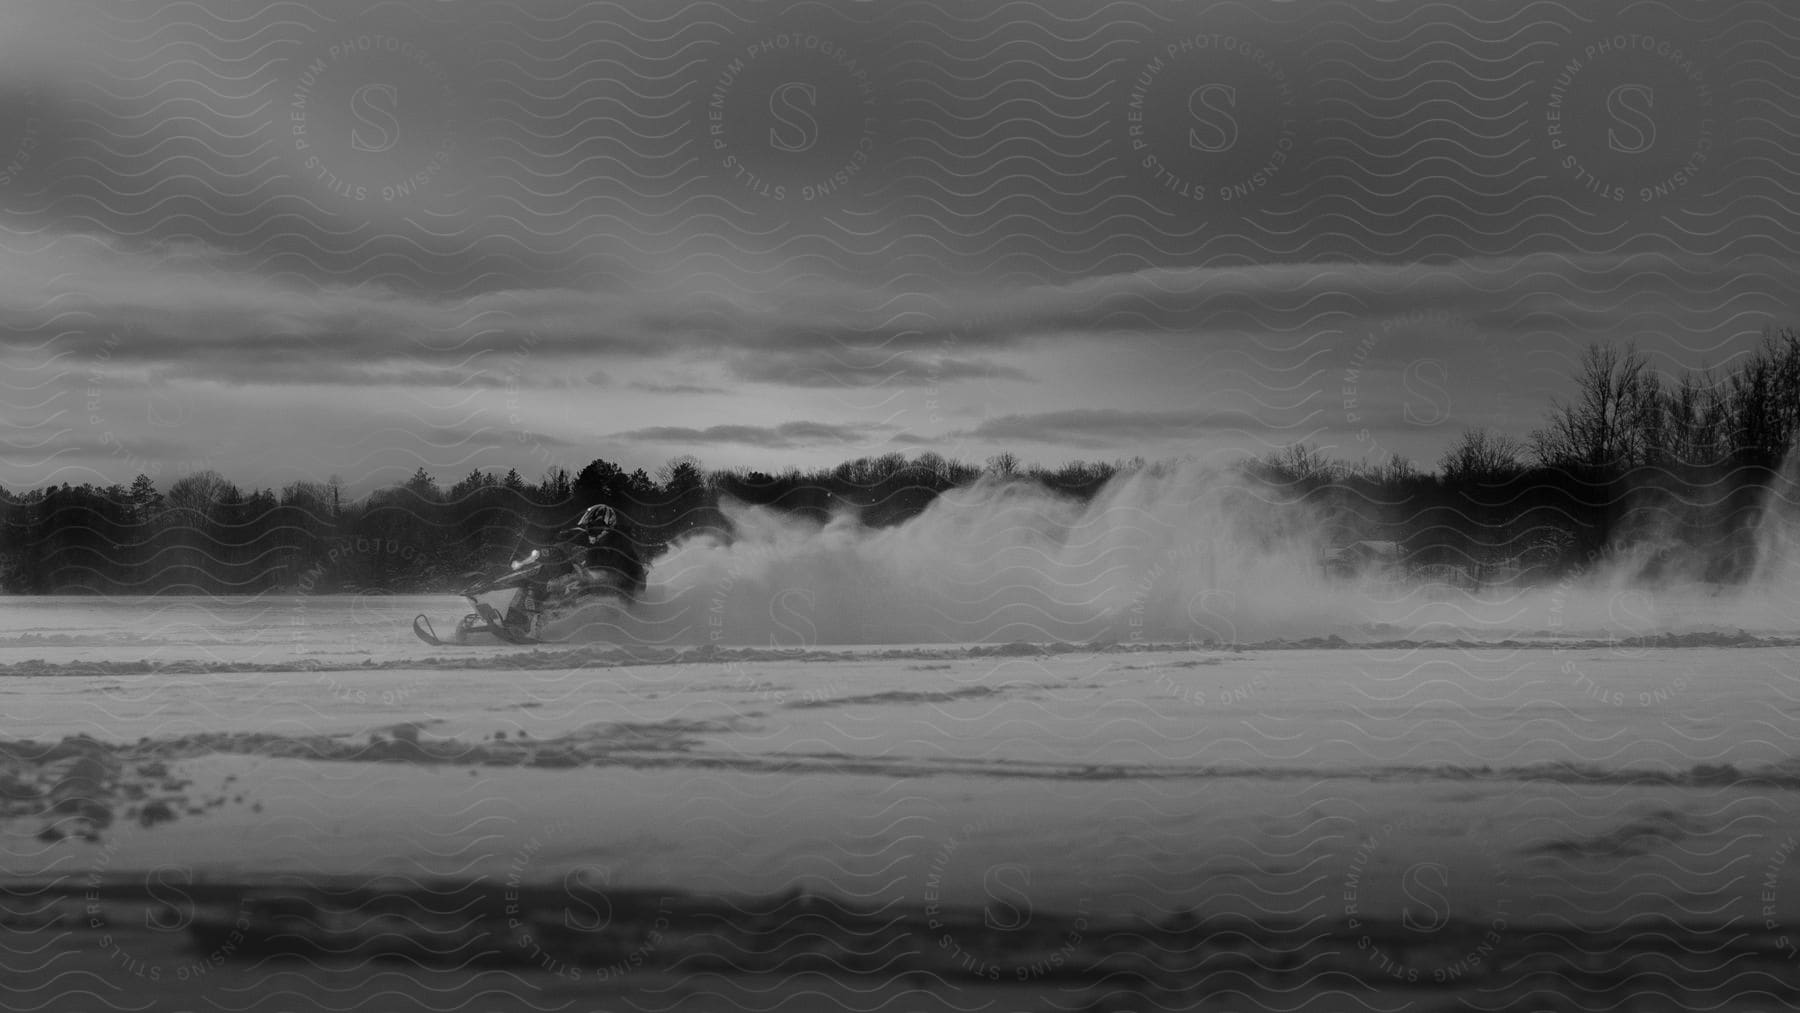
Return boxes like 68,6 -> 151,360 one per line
561,464 -> 1800,648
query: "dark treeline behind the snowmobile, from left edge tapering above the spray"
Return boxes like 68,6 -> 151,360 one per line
0,453 -> 1116,594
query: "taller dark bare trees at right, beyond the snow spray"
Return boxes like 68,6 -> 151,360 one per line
1255,327 -> 1800,585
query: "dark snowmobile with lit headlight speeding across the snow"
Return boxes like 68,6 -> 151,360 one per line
412,545 -> 644,646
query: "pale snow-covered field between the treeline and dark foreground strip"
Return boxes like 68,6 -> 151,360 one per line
0,597 -> 1800,1007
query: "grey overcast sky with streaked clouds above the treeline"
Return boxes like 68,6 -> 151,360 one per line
0,0 -> 1800,489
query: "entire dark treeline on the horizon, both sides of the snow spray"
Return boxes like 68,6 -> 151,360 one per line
0,329 -> 1800,594
